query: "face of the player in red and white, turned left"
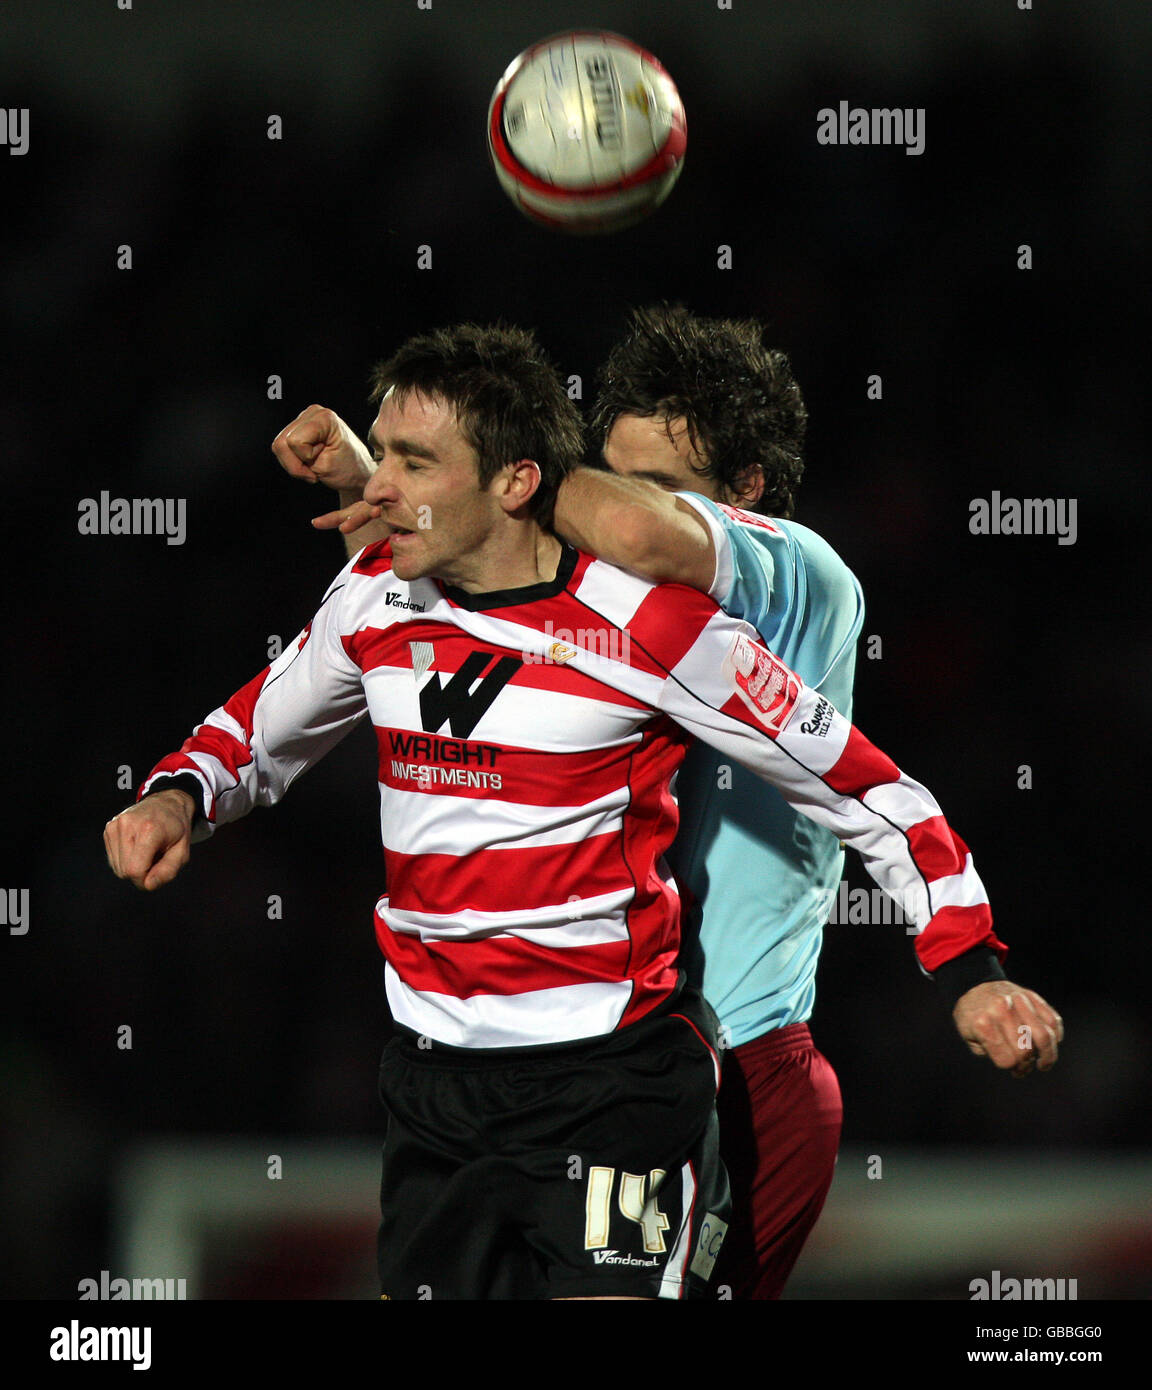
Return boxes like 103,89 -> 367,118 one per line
364,392 -> 503,584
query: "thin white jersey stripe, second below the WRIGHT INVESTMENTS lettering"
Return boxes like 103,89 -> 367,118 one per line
377,888 -> 635,947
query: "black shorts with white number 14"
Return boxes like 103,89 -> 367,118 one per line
379,988 -> 728,1300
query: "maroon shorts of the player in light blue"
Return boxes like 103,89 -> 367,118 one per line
713,1023 -> 844,1298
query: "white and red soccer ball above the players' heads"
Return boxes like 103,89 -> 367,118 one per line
488,29 -> 688,232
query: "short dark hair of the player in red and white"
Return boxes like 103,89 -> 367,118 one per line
372,324 -> 584,525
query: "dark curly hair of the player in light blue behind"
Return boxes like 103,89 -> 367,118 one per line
592,304 -> 807,517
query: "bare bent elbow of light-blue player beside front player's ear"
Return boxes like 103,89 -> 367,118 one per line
554,468 -> 716,592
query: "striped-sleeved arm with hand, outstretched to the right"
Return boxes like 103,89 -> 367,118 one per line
634,594 -> 1063,1076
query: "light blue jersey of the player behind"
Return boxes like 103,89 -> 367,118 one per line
668,493 -> 864,1047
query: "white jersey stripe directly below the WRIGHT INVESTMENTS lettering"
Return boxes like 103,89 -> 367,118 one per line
381,783 -> 630,856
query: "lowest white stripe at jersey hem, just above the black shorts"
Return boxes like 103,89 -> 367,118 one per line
385,965 -> 632,1047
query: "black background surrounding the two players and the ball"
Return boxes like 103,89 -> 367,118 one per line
0,0 -> 1152,1298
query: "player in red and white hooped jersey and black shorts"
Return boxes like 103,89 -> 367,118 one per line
106,319 -> 1028,1298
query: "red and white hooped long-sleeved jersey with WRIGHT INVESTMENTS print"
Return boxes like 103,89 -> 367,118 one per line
140,542 -> 1003,1047
